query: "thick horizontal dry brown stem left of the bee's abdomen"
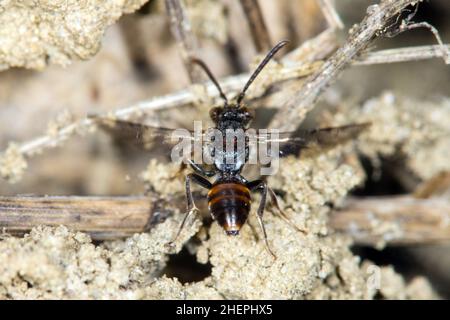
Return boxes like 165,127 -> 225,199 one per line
0,197 -> 154,240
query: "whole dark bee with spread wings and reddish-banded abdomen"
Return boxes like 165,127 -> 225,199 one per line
96,41 -> 367,256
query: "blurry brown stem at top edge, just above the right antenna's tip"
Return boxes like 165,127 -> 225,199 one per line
240,0 -> 272,52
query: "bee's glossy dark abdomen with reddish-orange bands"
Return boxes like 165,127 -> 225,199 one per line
208,182 -> 250,235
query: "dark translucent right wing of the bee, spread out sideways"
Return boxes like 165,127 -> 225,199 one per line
249,123 -> 370,156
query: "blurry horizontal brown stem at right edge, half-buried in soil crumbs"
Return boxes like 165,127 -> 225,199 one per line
330,196 -> 450,246
